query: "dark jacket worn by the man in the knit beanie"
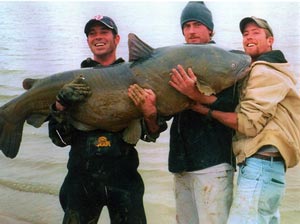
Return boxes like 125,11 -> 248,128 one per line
169,72 -> 239,173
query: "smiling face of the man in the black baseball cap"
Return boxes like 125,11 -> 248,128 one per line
87,24 -> 120,66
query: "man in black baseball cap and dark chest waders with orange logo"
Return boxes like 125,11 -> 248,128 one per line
49,16 -> 146,224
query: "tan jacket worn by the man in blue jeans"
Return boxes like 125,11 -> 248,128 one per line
233,61 -> 300,168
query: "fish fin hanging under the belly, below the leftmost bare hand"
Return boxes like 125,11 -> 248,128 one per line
123,119 -> 142,145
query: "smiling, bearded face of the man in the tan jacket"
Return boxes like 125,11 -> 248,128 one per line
243,22 -> 274,60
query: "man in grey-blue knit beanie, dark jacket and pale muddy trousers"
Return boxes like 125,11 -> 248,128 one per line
128,2 -> 238,224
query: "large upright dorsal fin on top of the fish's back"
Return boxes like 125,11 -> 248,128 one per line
128,33 -> 154,61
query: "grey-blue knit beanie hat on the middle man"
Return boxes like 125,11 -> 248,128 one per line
180,1 -> 214,31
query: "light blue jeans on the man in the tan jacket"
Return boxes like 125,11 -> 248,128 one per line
227,158 -> 285,224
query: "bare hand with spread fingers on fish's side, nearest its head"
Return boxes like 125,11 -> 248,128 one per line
169,65 -> 199,100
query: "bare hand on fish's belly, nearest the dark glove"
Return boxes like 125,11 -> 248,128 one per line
128,84 -> 157,117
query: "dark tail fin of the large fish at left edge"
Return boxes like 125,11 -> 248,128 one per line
0,111 -> 25,158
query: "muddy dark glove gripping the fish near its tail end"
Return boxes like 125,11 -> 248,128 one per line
56,75 -> 92,107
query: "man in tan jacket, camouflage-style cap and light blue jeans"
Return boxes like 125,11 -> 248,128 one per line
194,17 -> 300,224
